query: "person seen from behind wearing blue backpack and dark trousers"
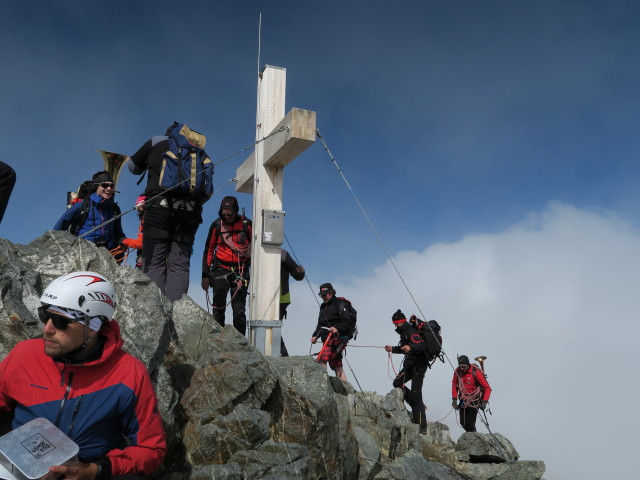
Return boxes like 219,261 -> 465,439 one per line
129,122 -> 213,301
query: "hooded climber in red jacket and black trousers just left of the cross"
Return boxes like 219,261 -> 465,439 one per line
201,196 -> 252,335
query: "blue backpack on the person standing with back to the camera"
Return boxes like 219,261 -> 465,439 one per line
159,122 -> 213,203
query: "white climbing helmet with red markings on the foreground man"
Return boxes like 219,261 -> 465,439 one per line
40,272 -> 116,321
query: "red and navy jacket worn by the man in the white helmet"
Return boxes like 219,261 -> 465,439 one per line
0,320 -> 166,475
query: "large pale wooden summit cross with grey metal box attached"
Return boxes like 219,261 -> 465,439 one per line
236,65 -> 316,357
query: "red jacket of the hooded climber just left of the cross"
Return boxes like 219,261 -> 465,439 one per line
202,215 -> 252,278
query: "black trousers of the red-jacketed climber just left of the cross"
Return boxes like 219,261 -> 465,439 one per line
210,267 -> 249,335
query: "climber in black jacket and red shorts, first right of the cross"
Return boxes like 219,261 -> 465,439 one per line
311,283 -> 358,382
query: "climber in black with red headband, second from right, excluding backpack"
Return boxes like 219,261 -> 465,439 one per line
384,309 -> 429,434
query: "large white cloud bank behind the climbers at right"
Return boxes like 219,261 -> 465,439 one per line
191,203 -> 640,480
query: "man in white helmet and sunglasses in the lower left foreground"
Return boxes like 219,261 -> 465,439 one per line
0,272 -> 167,480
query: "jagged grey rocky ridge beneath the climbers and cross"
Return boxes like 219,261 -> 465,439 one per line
0,232 -> 544,480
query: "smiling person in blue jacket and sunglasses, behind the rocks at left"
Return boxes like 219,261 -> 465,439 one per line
53,171 -> 125,261
